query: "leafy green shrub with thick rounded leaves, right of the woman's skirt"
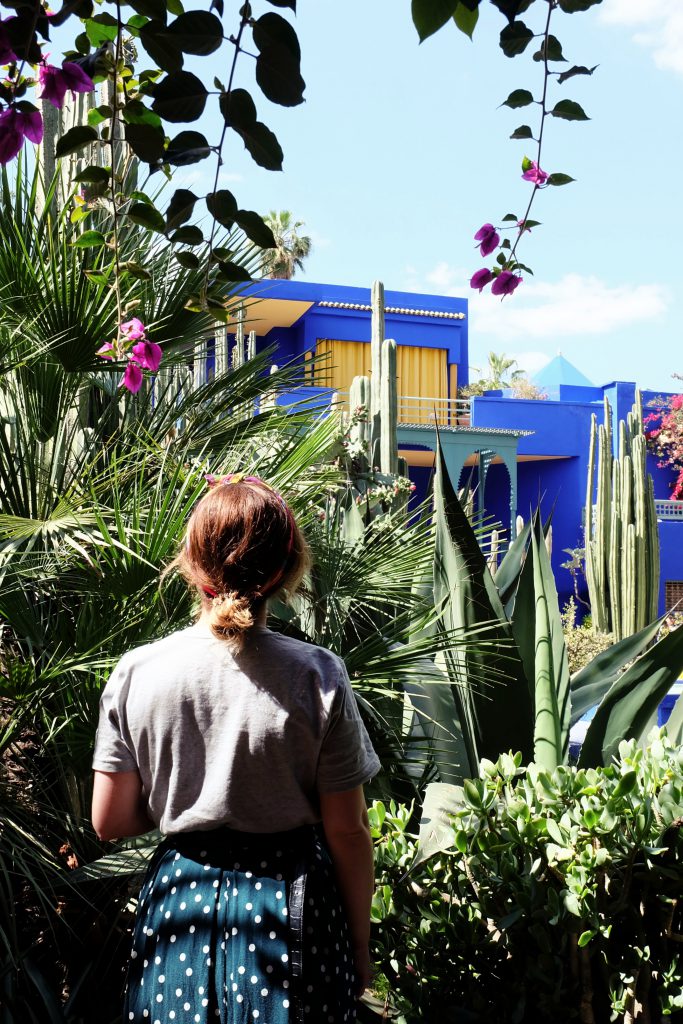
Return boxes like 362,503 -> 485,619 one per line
371,730 -> 683,1024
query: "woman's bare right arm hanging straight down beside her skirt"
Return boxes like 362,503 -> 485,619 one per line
319,785 -> 375,995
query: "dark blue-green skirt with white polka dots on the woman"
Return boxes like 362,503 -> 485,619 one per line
124,826 -> 355,1024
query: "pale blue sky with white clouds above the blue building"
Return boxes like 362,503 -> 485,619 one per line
169,0 -> 683,390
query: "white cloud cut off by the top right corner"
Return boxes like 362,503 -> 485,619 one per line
600,0 -> 683,75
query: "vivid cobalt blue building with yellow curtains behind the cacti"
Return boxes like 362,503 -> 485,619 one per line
236,281 -> 683,610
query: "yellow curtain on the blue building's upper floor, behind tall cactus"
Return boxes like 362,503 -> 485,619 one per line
315,338 -> 449,423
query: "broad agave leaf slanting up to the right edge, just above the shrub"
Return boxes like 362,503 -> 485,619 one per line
579,629 -> 683,768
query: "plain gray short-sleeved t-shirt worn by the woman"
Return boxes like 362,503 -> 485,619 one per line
93,623 -> 380,833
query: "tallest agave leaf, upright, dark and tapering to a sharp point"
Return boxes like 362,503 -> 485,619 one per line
434,445 -> 532,775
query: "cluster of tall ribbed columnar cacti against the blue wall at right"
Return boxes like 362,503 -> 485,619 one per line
585,391 -> 659,640
